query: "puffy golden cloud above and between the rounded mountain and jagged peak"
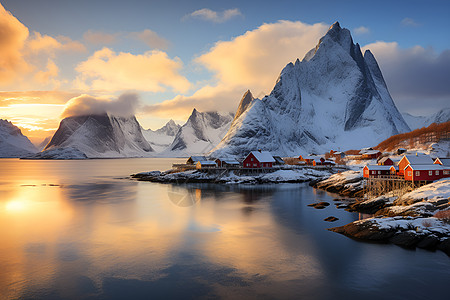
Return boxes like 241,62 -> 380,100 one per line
76,48 -> 190,93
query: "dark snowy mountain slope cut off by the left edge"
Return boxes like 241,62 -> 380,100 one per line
0,119 -> 38,158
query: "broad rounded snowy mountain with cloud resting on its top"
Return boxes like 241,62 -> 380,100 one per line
33,114 -> 154,159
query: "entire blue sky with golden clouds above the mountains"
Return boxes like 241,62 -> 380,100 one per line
0,0 -> 450,143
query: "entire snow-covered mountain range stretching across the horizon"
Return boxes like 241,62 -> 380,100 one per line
0,22 -> 450,159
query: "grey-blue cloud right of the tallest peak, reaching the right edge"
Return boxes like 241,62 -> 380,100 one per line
363,42 -> 450,114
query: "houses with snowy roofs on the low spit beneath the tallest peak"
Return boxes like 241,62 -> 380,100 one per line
186,150 -> 285,169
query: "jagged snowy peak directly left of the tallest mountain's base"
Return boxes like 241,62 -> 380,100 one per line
161,108 -> 233,157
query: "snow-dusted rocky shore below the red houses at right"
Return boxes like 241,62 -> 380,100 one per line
310,171 -> 450,256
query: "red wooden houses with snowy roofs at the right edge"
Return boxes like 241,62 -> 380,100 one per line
363,153 -> 450,181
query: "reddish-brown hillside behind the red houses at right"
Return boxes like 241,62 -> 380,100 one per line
375,121 -> 450,151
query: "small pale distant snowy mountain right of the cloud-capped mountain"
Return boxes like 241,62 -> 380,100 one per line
142,120 -> 181,152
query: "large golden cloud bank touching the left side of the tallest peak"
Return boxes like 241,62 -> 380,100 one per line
145,21 -> 329,118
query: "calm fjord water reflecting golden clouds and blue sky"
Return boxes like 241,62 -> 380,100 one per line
0,159 -> 450,299
